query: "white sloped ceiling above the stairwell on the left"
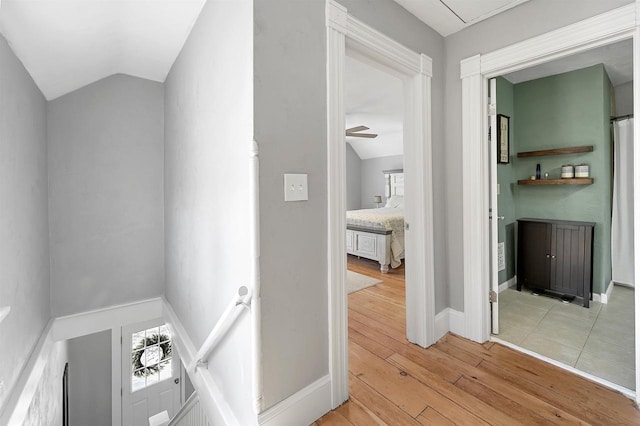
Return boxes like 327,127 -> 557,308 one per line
0,0 -> 205,100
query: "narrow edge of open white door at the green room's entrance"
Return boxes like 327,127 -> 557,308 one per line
489,78 -> 500,334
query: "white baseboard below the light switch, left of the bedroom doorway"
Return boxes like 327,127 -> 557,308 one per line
258,375 -> 331,426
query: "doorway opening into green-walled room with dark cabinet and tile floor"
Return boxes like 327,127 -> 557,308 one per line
491,39 -> 635,390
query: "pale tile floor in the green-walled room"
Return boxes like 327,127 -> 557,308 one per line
496,286 -> 635,390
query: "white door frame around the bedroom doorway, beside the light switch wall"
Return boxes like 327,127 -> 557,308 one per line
326,0 -> 435,407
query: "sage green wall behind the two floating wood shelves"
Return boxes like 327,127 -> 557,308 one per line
510,65 -> 611,293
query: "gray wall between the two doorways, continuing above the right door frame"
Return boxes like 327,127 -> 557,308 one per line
442,0 -> 630,311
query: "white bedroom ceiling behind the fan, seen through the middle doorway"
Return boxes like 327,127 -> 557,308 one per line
345,57 -> 403,160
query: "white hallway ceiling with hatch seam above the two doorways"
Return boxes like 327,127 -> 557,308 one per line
395,0 -> 529,37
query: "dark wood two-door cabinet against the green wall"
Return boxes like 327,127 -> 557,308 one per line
517,219 -> 595,308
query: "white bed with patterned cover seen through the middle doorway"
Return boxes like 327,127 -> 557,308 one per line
346,170 -> 404,274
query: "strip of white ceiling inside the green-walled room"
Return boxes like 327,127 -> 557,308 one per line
504,39 -> 633,86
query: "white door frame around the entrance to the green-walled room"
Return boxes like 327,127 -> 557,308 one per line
460,0 -> 640,402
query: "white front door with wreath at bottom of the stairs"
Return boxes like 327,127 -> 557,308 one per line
122,319 -> 180,426
